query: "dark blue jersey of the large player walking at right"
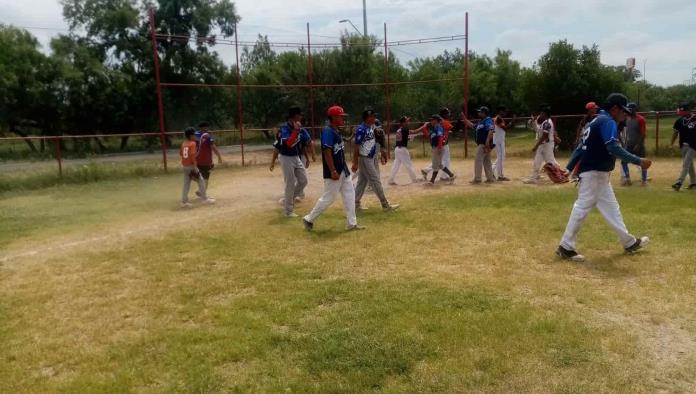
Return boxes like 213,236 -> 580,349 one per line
578,111 -> 619,173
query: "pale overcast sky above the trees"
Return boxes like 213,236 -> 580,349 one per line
0,0 -> 696,85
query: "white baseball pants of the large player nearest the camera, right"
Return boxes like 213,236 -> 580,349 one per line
561,171 -> 636,250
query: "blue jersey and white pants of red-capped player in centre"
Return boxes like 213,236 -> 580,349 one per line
304,126 -> 358,228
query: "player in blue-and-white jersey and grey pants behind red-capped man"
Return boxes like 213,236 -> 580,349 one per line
352,109 -> 399,211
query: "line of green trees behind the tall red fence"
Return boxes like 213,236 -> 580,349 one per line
0,0 -> 696,154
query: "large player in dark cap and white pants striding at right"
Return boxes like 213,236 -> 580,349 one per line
556,93 -> 652,262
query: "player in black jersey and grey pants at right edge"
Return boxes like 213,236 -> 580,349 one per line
672,103 -> 696,191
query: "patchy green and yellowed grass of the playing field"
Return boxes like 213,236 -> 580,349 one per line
0,162 -> 696,393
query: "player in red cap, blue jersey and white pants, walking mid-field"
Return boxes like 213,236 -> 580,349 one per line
302,105 -> 365,231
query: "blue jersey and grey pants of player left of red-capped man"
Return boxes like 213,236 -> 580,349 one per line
273,122 -> 309,215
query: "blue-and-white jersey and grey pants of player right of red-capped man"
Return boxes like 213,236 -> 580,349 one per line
355,123 -> 389,208
